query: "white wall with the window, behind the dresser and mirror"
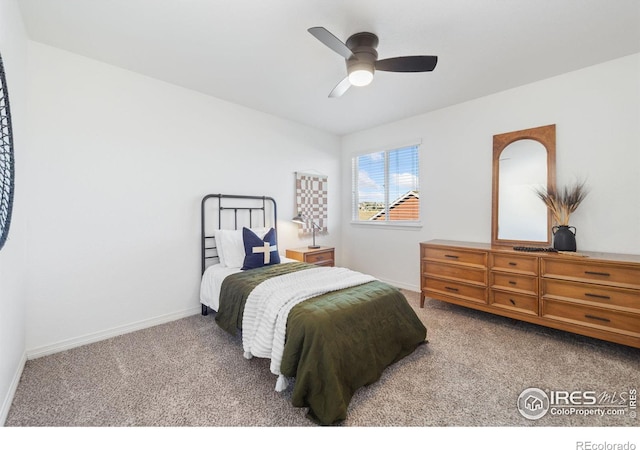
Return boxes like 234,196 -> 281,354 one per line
341,54 -> 640,290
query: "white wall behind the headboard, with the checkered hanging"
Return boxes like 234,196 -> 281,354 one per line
27,43 -> 341,356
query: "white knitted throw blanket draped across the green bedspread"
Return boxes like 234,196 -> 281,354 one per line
242,267 -> 375,392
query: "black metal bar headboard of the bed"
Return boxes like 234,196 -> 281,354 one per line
200,194 -> 278,274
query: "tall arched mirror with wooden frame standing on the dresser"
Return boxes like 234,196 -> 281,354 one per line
491,125 -> 556,246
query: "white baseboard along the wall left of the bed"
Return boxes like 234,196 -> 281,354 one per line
27,306 -> 201,359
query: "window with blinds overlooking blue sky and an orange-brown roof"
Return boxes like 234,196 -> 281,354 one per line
352,144 -> 420,224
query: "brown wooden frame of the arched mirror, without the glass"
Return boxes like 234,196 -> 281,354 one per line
491,124 -> 556,247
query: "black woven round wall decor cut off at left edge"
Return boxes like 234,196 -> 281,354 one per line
0,52 -> 14,249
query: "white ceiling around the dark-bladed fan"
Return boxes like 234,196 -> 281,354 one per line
18,0 -> 640,135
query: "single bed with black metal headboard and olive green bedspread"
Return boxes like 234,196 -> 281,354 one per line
200,194 -> 427,425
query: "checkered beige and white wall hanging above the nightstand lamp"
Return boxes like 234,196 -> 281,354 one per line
296,172 -> 329,234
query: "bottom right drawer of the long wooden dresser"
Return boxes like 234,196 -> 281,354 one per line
542,299 -> 640,337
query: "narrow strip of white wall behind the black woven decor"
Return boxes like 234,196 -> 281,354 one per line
0,0 -> 28,425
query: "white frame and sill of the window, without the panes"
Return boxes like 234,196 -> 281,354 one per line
350,139 -> 422,230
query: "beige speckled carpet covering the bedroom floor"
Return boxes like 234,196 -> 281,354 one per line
6,292 -> 640,427
